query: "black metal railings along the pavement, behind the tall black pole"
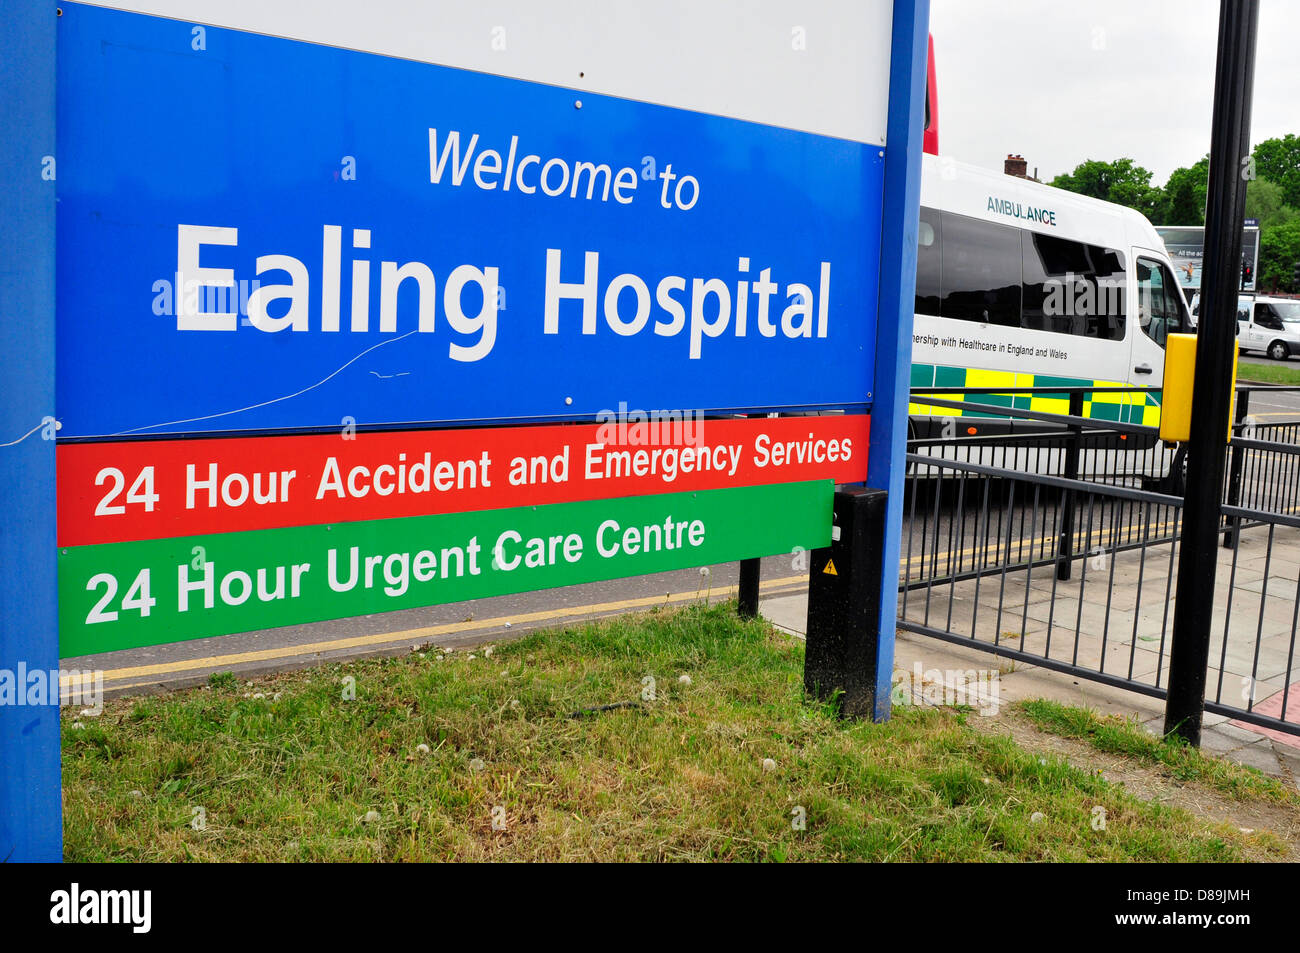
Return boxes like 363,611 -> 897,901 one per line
898,387 -> 1300,735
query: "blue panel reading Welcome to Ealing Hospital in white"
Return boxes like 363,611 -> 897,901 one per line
57,4 -> 884,437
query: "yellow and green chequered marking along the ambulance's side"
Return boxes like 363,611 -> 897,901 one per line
907,364 -> 1161,426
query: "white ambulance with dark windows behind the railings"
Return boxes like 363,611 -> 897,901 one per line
910,155 -> 1190,436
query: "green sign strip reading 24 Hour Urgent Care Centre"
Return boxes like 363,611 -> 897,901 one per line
59,480 -> 833,658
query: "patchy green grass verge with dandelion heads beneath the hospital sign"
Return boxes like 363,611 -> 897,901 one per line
62,603 -> 1279,861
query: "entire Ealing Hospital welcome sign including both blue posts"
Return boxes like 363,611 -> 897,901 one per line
0,0 -> 928,861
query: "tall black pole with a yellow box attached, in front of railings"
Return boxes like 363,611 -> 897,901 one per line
1165,0 -> 1260,745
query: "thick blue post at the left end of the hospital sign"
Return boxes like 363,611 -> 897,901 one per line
0,0 -> 62,862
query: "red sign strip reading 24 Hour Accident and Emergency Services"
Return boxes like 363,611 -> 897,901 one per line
57,415 -> 870,546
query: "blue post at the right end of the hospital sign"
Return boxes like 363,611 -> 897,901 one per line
867,0 -> 930,722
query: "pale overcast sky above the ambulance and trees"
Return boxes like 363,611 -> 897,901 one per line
930,0 -> 1300,186
